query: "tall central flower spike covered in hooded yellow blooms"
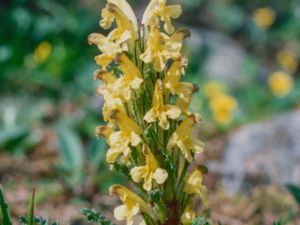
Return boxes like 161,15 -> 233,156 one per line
88,0 -> 206,225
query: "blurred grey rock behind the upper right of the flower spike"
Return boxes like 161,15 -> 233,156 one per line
187,29 -> 249,87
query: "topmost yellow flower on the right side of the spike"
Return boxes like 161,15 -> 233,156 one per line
142,0 -> 182,33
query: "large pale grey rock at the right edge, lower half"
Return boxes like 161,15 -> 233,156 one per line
222,110 -> 300,194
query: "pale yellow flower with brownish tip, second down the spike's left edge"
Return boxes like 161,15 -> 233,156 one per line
88,30 -> 130,70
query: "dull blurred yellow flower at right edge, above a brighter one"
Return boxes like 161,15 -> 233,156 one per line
277,49 -> 298,72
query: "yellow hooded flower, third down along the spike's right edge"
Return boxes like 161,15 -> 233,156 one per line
163,58 -> 194,102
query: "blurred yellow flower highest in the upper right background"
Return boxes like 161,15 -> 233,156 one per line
253,7 -> 276,29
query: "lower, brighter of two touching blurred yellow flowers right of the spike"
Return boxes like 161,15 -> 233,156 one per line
209,94 -> 237,124
